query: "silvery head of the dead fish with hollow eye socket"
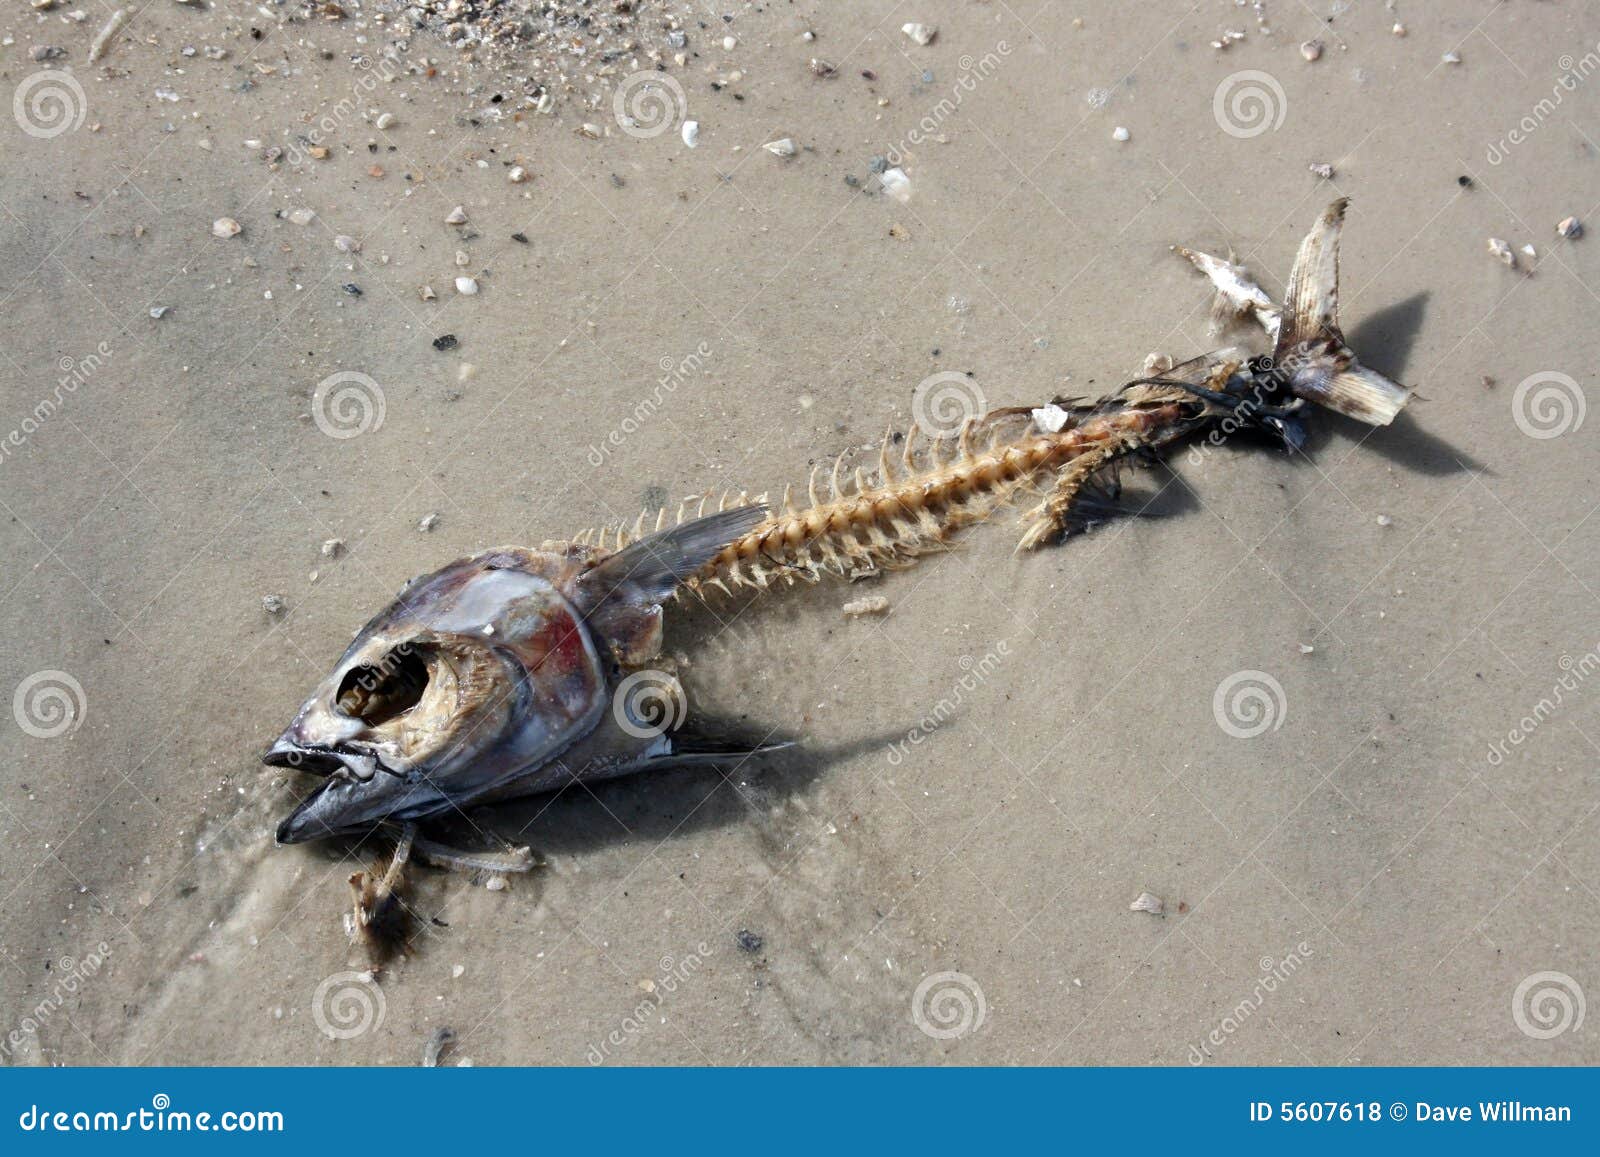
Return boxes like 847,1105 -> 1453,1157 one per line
264,549 -> 606,843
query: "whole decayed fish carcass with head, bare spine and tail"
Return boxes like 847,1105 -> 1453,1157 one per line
264,200 -> 1410,960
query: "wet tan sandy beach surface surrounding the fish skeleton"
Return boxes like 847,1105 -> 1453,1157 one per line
0,0 -> 1600,1066
